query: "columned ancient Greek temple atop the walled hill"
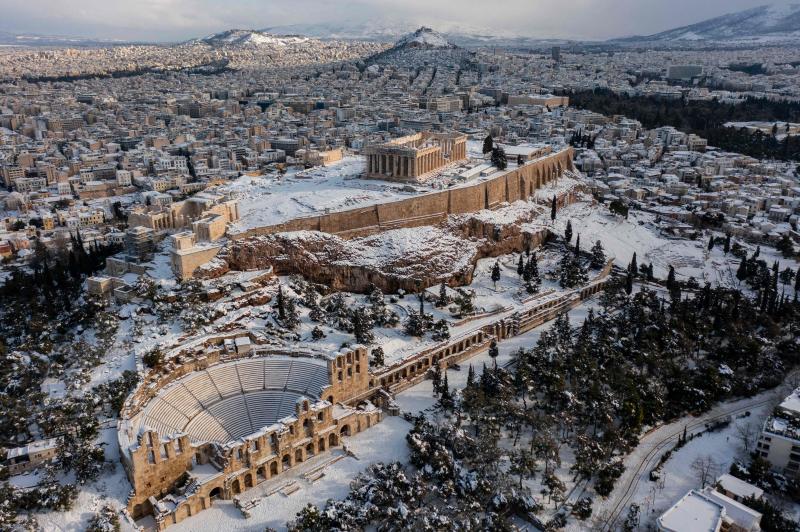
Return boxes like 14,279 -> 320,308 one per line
365,132 -> 467,181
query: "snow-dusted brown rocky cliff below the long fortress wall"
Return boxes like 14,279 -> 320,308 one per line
206,197 -> 568,293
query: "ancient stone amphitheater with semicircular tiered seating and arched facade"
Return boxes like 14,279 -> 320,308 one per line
118,346 -> 382,530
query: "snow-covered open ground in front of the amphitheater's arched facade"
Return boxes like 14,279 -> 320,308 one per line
170,417 -> 411,532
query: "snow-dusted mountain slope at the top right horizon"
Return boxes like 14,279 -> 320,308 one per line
614,3 -> 800,43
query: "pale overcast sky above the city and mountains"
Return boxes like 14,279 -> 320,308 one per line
0,0 -> 798,41
